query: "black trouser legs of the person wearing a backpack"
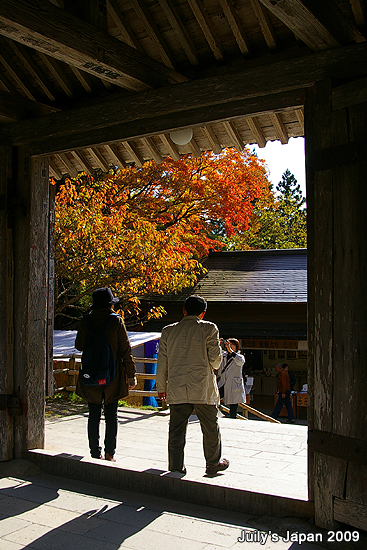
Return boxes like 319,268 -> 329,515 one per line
88,401 -> 118,458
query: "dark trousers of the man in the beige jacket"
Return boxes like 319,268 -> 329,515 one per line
168,403 -> 222,470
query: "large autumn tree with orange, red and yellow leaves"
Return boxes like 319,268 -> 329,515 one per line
55,148 -> 270,326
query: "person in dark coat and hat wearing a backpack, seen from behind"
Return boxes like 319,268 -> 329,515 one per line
75,288 -> 136,462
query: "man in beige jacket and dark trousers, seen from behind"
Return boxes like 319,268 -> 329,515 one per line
157,295 -> 229,475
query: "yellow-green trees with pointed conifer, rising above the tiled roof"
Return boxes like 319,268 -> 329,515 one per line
236,169 -> 307,249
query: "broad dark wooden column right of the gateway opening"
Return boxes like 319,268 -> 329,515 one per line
305,81 -> 367,529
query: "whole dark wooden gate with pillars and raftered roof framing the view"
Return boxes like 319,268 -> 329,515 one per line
0,0 -> 367,529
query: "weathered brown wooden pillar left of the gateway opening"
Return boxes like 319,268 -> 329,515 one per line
12,148 -> 49,458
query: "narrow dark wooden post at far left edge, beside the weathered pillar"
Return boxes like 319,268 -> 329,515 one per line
0,147 -> 14,461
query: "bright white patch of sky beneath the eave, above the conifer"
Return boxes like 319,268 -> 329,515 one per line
250,138 -> 306,196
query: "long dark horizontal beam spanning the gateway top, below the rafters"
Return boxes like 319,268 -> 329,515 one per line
0,44 -> 367,154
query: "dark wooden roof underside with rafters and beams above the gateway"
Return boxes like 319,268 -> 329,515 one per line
0,0 -> 367,178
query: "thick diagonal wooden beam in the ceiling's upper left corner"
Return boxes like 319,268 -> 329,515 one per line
0,0 -> 187,90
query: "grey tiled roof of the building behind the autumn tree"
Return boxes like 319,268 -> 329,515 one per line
152,249 -> 307,303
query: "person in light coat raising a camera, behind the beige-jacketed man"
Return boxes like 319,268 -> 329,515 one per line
217,338 -> 246,418
